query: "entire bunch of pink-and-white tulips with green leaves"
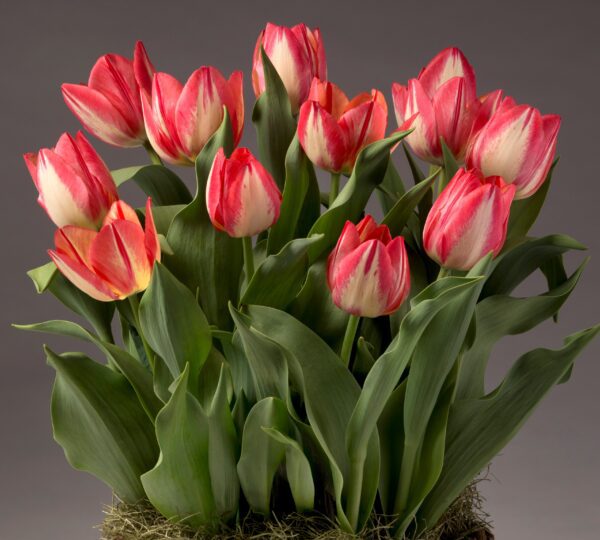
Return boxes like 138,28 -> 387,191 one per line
16,24 -> 599,538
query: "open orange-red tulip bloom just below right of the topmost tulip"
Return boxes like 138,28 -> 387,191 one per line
298,79 -> 387,173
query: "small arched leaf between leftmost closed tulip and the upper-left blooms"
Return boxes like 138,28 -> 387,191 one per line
112,165 -> 192,206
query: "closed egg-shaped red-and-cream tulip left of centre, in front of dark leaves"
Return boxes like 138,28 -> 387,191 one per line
206,148 -> 281,238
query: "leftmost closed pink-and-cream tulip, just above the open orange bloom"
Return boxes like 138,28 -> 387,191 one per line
23,132 -> 119,229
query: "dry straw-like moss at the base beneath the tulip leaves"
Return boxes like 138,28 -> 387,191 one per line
100,484 -> 494,540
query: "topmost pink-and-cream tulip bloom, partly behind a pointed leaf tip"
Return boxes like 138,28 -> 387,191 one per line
252,23 -> 327,114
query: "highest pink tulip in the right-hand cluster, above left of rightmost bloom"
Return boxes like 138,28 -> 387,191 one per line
392,48 -> 480,164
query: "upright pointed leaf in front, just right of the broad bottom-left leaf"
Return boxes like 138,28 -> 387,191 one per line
142,368 -> 218,528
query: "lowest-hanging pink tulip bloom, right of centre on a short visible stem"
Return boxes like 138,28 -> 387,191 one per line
327,216 -> 410,317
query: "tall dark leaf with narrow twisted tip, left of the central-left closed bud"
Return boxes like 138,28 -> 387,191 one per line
164,111 -> 243,329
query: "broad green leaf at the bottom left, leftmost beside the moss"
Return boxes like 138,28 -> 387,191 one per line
46,348 -> 158,503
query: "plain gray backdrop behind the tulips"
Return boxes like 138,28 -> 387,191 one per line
0,0 -> 600,540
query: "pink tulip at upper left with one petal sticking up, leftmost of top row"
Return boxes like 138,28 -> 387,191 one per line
62,41 -> 154,147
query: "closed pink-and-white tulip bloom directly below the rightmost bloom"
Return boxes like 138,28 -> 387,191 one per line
423,169 -> 515,270
